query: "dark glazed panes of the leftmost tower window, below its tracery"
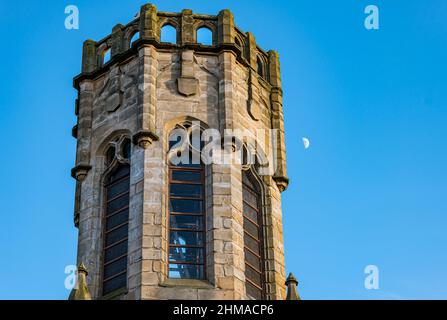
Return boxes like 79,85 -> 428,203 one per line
103,165 -> 130,295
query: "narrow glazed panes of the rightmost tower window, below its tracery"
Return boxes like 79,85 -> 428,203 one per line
242,170 -> 265,300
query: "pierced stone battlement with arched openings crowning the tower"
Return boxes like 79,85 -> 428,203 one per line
74,4 -> 280,88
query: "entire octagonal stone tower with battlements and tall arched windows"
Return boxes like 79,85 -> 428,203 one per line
72,4 -> 288,300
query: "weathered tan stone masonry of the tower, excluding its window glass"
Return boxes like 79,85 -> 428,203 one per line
72,4 -> 288,299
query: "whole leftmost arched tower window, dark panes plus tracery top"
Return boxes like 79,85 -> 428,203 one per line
102,139 -> 131,295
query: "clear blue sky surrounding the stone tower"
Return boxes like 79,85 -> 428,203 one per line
0,0 -> 447,299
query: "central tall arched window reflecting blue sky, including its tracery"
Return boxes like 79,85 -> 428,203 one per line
169,127 -> 206,279
